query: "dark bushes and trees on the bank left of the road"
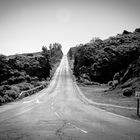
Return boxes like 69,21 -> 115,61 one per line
0,43 -> 63,104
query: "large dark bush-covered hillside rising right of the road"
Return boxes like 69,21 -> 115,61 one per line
68,28 -> 140,96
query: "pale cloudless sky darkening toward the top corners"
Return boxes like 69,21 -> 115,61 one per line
0,0 -> 140,55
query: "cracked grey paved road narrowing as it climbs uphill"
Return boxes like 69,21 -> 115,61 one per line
0,56 -> 140,140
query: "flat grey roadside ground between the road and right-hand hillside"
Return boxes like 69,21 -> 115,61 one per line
78,84 -> 140,120
